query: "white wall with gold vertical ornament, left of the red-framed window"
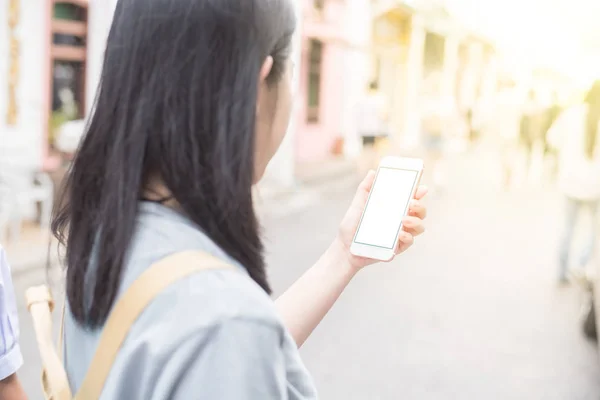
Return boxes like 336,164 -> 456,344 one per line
0,0 -> 51,166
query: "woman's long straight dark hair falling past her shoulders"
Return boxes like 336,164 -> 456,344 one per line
52,0 -> 296,327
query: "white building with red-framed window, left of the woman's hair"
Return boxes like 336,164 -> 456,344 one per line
0,0 -> 112,169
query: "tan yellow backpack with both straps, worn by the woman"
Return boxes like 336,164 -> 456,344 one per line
25,251 -> 235,400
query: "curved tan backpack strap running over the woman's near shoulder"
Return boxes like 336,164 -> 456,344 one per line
76,251 -> 235,400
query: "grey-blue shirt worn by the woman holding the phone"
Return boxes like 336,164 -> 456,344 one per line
65,202 -> 317,400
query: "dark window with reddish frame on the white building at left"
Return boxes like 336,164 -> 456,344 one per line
49,0 -> 88,144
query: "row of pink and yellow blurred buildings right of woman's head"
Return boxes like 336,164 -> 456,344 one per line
295,0 -> 494,159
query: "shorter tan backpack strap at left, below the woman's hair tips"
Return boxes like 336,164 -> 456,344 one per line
25,286 -> 72,400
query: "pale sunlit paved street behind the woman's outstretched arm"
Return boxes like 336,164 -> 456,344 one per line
9,145 -> 600,400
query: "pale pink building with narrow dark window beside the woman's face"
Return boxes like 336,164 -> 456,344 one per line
293,0 -> 371,164
